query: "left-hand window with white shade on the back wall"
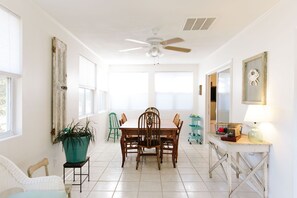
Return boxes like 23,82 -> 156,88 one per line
109,72 -> 148,110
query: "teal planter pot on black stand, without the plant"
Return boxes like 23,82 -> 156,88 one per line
63,137 -> 90,163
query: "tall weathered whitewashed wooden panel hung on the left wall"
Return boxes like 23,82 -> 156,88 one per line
51,37 -> 67,143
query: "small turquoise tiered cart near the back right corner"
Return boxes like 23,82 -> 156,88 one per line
188,114 -> 203,144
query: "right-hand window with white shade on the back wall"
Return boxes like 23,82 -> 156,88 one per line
155,72 -> 193,110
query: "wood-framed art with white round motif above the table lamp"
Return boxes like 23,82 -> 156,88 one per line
242,52 -> 267,105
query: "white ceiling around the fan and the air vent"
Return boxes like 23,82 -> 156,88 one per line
33,0 -> 279,64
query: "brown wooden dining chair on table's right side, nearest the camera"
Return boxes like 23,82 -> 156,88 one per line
160,121 -> 184,166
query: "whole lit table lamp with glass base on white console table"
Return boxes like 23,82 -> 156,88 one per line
244,105 -> 265,142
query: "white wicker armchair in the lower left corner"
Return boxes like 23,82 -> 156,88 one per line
0,155 -> 66,197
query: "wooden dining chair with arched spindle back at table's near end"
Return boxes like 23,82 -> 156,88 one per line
136,111 -> 161,170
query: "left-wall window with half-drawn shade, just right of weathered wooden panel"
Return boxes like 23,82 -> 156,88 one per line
79,56 -> 96,117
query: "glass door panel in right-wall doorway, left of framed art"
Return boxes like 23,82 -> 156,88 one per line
216,68 -> 231,122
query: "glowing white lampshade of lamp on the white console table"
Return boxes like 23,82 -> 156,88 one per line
244,105 -> 267,122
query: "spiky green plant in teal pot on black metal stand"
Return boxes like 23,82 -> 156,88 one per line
55,119 -> 95,163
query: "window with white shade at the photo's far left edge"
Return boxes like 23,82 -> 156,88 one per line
0,6 -> 21,139
